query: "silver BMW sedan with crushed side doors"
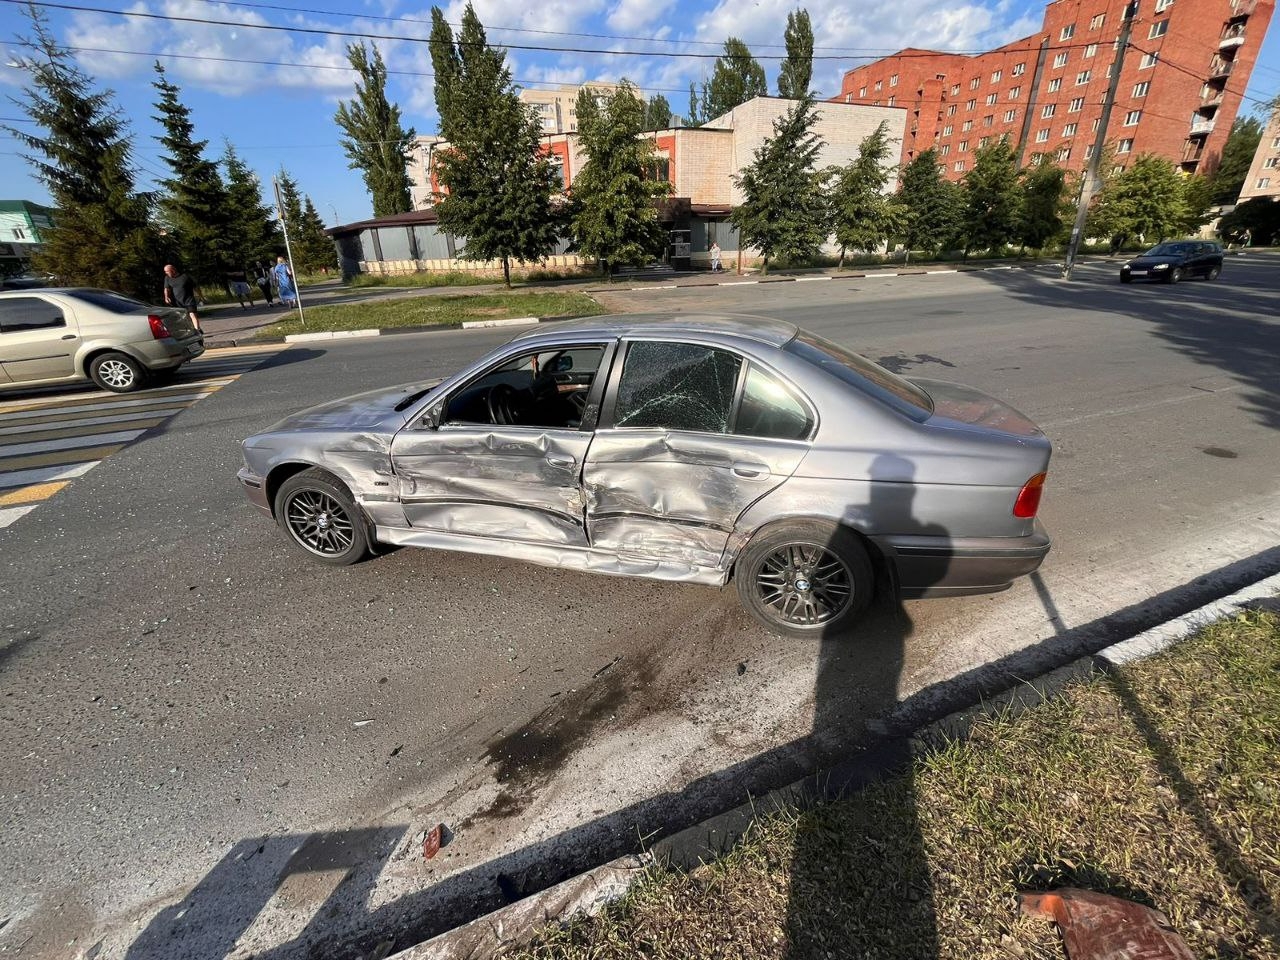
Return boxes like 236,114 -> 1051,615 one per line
239,316 -> 1051,636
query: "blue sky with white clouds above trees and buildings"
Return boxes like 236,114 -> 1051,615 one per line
0,0 -> 1280,223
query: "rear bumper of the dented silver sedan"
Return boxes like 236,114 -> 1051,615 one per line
872,520 -> 1050,598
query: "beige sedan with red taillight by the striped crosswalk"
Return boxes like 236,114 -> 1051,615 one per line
0,287 -> 205,393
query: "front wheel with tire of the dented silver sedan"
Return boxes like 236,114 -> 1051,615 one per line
273,467 -> 370,567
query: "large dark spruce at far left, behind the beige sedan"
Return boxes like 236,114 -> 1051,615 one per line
3,5 -> 165,301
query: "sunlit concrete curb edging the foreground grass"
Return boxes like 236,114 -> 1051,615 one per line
388,573 -> 1280,960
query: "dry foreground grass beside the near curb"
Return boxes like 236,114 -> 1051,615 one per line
513,612 -> 1280,960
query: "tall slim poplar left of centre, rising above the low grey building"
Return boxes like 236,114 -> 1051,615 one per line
333,44 -> 413,216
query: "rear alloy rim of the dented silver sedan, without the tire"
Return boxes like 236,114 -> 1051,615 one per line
755,543 -> 854,627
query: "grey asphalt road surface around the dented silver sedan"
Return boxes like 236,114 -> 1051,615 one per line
0,257 -> 1280,960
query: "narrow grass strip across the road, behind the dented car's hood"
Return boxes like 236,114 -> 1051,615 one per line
257,292 -> 605,337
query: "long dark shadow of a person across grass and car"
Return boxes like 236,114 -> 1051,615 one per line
785,454 -> 947,960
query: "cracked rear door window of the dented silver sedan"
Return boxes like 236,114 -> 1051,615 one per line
613,340 -> 741,434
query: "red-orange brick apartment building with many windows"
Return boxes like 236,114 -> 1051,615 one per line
833,0 -> 1275,179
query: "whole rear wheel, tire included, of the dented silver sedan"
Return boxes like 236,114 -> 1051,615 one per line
733,520 -> 876,639
